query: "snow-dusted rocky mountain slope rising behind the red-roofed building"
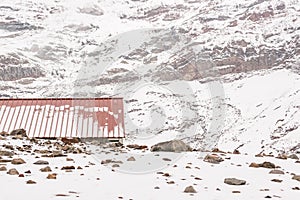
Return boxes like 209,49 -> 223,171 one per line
0,0 -> 300,151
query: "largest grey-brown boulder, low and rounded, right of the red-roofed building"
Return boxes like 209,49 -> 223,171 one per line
151,140 -> 192,152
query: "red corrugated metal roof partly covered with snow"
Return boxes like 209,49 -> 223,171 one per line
0,98 -> 125,138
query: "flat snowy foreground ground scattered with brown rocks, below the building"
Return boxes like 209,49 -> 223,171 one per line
0,138 -> 300,200
